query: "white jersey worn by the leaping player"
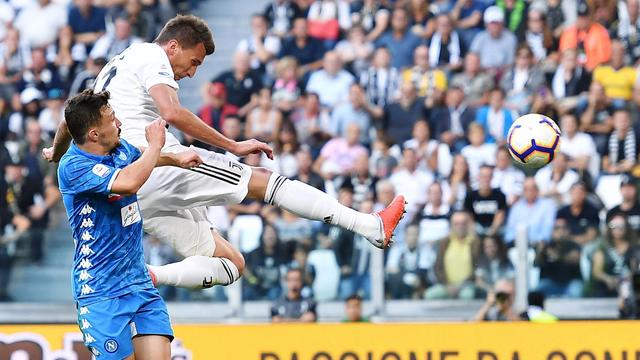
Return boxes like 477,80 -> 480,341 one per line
94,43 -> 180,147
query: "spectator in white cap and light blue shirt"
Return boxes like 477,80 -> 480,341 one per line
470,6 -> 517,71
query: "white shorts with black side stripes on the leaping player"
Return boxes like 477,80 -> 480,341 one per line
138,145 -> 251,257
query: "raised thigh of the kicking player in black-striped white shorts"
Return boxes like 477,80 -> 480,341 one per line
138,145 -> 252,212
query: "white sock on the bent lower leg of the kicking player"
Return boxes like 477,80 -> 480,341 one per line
147,255 -> 240,289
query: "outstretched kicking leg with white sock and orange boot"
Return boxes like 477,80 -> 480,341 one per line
247,168 -> 406,248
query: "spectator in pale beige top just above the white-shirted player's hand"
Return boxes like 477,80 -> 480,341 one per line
244,88 -> 282,142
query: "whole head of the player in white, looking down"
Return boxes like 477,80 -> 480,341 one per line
154,15 -> 215,80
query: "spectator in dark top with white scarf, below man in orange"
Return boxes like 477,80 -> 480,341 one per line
547,49 -> 591,114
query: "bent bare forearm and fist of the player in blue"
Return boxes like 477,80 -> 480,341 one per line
111,118 -> 166,195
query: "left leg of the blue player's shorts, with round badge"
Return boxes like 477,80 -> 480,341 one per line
78,295 -> 137,360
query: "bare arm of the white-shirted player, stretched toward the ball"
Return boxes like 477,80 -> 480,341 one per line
149,84 -> 273,159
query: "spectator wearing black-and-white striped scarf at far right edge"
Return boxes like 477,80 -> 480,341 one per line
602,109 -> 640,174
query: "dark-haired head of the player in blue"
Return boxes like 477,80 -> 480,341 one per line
64,89 -> 121,151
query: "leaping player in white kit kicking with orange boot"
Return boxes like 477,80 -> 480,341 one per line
43,15 -> 405,288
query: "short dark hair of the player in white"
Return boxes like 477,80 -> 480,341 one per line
154,15 -> 216,55
